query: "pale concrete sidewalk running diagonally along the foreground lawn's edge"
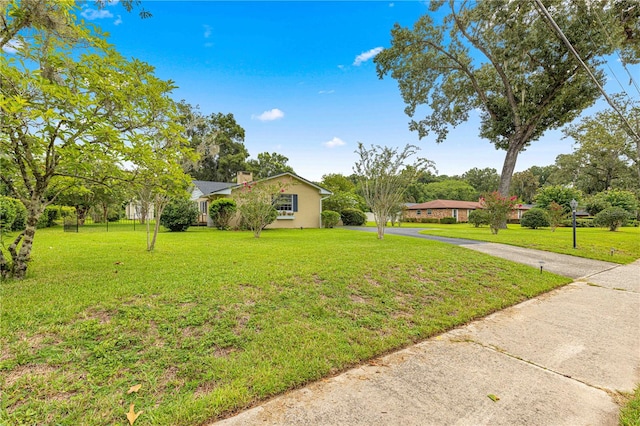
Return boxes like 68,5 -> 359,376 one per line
216,231 -> 640,426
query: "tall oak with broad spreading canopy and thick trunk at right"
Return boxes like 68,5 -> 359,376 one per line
375,0 -> 640,195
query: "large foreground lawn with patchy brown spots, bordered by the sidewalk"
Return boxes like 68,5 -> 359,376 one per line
0,228 -> 569,426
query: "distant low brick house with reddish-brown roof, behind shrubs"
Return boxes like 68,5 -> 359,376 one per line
404,200 -> 533,222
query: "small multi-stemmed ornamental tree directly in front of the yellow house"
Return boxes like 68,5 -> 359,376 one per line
235,182 -> 285,238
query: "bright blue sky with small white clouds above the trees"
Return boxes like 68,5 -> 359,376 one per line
76,1 -> 640,181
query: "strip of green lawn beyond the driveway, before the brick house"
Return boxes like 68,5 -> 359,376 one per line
402,223 -> 640,264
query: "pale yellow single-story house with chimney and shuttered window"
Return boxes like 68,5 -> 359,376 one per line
191,172 -> 333,228
